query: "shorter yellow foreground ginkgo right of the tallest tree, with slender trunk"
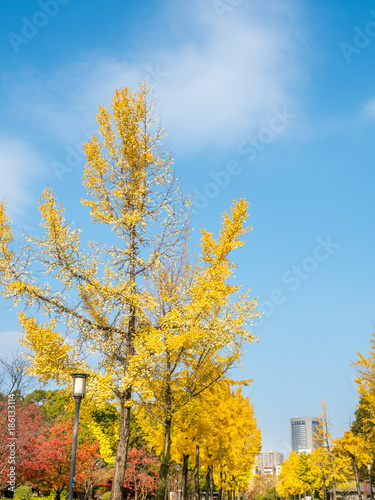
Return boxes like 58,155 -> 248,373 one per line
134,199 -> 258,500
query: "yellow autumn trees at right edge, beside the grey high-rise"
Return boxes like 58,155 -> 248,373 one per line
277,334 -> 375,500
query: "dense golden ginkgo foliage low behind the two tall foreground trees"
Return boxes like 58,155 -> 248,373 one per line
138,377 -> 261,500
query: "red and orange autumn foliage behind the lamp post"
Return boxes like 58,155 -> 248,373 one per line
0,391 -> 164,500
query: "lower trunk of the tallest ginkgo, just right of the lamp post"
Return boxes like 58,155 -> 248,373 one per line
111,389 -> 131,500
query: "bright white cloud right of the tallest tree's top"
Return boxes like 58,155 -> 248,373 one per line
158,15 -> 300,152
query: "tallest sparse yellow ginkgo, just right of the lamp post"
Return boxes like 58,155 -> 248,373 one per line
0,84 -> 188,500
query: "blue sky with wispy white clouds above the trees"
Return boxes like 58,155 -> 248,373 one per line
0,0 -> 375,453
